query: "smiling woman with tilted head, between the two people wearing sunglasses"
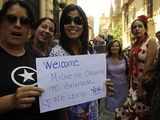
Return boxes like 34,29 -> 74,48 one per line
31,17 -> 56,57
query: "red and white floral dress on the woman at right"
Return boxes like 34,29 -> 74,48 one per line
116,39 -> 150,120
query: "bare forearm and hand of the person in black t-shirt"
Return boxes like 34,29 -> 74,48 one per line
0,86 -> 43,113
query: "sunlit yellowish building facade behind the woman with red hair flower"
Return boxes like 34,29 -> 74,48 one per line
121,0 -> 160,47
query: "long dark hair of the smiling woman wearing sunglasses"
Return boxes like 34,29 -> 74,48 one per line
60,4 -> 88,54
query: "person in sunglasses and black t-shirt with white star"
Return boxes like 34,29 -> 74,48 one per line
0,0 -> 60,120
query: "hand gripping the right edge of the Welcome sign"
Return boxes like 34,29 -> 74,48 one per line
106,79 -> 114,96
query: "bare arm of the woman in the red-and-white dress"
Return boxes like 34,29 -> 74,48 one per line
142,40 -> 160,96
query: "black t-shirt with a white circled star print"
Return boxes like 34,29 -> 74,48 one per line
0,47 -> 63,120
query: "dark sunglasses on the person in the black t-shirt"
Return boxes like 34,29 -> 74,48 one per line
4,15 -> 31,25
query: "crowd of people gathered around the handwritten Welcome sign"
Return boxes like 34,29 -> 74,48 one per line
0,0 -> 160,120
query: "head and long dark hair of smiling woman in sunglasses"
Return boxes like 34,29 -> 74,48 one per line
50,5 -> 88,55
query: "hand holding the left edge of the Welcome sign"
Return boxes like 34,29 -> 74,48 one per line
15,86 -> 43,109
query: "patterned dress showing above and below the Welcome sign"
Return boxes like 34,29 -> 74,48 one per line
49,45 -> 98,120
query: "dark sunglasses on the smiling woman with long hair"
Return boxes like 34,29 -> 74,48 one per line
64,16 -> 83,25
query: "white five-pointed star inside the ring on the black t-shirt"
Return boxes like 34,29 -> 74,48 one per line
19,69 -> 35,83
